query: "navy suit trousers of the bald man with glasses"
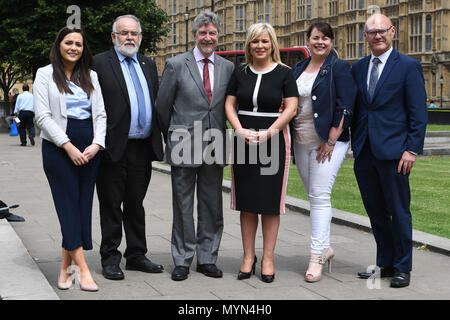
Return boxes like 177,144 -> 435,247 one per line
354,141 -> 412,272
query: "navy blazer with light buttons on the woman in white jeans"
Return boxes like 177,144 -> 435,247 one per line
294,52 -> 356,141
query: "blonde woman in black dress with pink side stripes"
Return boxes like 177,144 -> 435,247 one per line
225,23 -> 298,282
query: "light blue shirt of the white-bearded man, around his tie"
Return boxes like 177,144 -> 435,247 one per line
114,47 -> 152,139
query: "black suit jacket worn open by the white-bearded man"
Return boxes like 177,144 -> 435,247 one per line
93,48 -> 163,162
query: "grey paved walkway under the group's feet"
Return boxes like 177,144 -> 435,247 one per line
0,134 -> 450,300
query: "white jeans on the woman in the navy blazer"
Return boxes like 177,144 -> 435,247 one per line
294,141 -> 350,254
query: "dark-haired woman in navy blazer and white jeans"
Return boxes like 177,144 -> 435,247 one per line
292,22 -> 356,282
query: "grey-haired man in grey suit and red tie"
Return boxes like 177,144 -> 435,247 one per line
155,11 -> 234,281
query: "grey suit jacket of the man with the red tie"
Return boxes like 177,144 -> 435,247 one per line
156,50 -> 234,167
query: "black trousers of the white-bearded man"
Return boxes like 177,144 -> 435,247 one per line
97,139 -> 152,266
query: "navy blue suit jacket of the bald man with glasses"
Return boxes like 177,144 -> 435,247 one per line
351,49 -> 428,160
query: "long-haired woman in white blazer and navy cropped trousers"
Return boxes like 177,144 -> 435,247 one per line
33,27 -> 106,291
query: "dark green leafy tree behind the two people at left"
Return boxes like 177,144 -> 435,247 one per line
0,0 -> 168,88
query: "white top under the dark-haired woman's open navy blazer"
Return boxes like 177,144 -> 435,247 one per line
294,72 -> 321,144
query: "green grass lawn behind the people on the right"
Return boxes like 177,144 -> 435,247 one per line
224,156 -> 450,238
